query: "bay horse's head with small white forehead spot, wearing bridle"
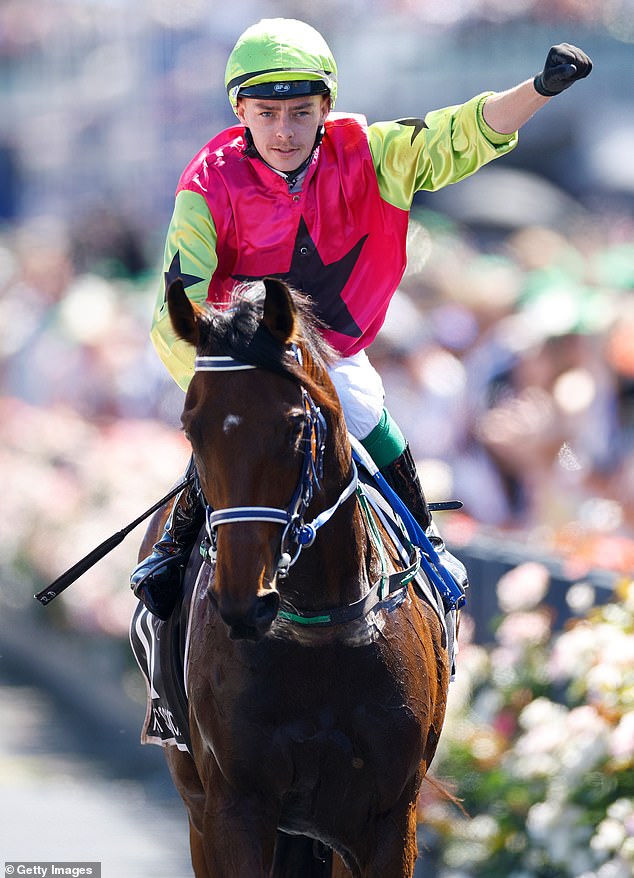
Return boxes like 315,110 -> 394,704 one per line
167,279 -> 349,639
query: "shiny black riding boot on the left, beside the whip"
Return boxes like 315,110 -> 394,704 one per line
130,460 -> 204,621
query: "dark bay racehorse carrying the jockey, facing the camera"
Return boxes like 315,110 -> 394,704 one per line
142,279 -> 449,878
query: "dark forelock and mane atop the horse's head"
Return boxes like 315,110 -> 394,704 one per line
197,282 -> 338,418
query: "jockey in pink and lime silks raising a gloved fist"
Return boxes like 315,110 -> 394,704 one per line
131,18 -> 592,618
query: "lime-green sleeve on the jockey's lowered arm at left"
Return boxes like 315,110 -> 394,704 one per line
150,190 -> 218,390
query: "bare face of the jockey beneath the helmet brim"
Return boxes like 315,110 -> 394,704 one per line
237,95 -> 330,172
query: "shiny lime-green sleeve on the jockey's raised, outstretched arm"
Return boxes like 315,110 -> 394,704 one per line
368,92 -> 517,210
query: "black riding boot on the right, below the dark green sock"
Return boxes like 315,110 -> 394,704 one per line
381,445 -> 469,592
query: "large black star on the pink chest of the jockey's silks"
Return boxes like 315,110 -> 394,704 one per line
232,217 -> 368,338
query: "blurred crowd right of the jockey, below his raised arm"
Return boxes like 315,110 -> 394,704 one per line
378,206 -> 634,571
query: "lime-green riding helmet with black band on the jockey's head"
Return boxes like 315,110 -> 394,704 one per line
225,18 -> 337,112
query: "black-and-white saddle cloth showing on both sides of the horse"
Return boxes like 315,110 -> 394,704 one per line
130,467 -> 457,752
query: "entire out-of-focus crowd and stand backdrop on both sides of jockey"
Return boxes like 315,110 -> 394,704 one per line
0,0 -> 634,631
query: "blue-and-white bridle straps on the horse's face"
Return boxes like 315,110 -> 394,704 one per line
194,346 -> 358,578
